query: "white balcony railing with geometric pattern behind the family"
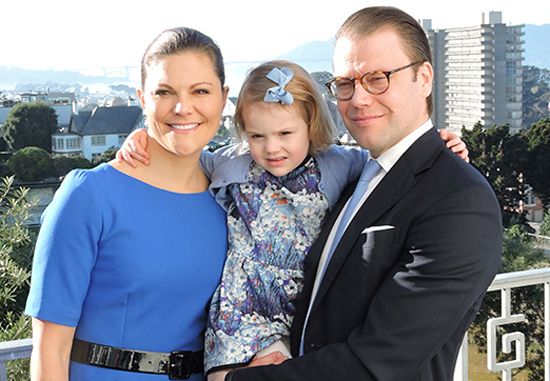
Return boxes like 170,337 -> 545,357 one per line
0,268 -> 550,381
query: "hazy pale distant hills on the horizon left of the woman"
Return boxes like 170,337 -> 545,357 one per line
0,66 -> 128,85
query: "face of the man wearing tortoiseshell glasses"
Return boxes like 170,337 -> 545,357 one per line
333,28 -> 433,157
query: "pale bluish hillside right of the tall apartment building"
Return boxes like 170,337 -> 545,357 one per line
524,24 -> 550,69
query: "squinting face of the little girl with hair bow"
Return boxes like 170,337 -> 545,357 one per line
243,102 -> 309,176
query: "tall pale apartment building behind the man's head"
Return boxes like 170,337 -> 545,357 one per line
421,12 -> 524,132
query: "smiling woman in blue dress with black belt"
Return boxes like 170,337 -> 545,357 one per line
26,28 -> 227,381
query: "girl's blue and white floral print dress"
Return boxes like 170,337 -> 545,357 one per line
205,158 -> 328,371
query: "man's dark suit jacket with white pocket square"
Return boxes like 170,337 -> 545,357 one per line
228,129 -> 502,381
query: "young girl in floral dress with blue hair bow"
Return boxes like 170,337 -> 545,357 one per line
119,60 -> 467,379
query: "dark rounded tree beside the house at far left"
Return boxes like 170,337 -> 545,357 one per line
1,102 -> 57,152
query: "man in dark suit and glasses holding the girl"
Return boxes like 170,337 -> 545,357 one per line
226,7 -> 502,381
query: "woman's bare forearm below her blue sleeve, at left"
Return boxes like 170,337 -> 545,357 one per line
31,318 -> 75,381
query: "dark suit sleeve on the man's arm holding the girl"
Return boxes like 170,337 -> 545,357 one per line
228,182 -> 502,381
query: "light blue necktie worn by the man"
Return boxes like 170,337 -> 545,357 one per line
299,159 -> 381,355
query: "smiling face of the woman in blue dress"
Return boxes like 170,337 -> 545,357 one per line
142,51 -> 228,157
